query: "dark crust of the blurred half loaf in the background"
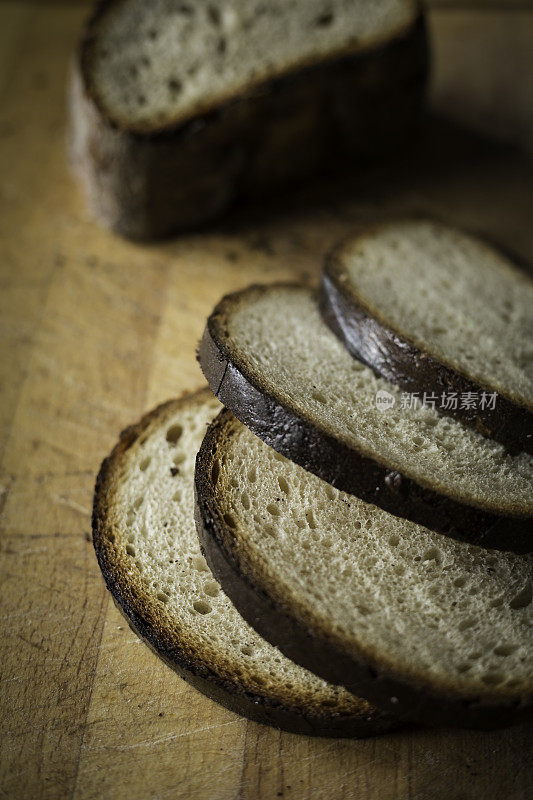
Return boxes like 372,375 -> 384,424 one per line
71,0 -> 428,239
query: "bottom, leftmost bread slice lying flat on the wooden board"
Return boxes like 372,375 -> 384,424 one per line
93,390 -> 397,736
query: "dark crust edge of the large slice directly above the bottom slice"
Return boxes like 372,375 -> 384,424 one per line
195,410 -> 533,729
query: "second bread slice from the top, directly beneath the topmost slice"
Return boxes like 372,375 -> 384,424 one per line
199,284 -> 533,552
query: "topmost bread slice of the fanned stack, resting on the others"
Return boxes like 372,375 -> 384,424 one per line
321,220 -> 533,453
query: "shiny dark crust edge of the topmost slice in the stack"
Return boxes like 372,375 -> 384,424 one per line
319,231 -> 533,454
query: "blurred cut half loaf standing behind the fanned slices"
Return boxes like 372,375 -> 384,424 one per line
71,0 -> 427,238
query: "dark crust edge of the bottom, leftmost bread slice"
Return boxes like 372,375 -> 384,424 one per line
92,389 -> 398,737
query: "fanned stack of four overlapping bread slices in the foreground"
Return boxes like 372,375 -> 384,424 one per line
93,220 -> 533,736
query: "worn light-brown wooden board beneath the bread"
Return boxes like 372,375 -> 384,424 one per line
0,2 -> 533,800
